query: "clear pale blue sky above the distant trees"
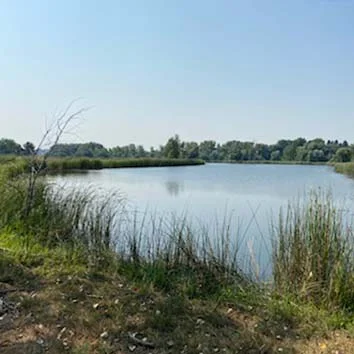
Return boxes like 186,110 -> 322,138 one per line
0,0 -> 354,147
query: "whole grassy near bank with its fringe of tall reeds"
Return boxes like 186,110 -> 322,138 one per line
0,167 -> 354,354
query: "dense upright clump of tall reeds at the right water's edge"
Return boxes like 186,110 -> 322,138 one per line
273,192 -> 354,309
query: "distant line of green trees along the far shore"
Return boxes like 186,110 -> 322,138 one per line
0,135 -> 354,162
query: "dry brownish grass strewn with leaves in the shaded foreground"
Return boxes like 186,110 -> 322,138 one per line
0,241 -> 294,353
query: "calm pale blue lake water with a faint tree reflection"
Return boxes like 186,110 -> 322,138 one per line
49,164 -> 354,276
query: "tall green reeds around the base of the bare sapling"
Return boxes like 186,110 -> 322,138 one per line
0,165 -> 123,264
